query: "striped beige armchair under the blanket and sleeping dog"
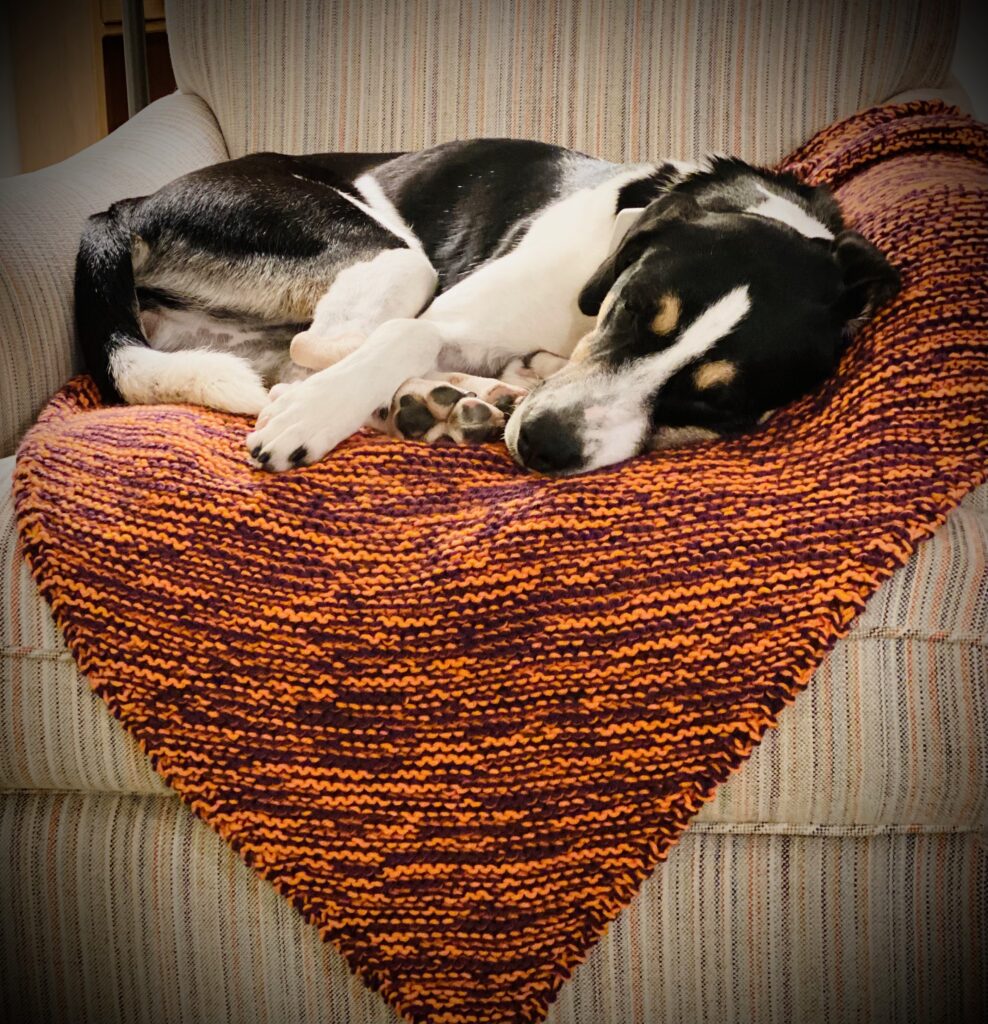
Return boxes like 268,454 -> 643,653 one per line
0,0 -> 988,1024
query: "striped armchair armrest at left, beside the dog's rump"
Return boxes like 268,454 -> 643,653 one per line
0,93 -> 228,457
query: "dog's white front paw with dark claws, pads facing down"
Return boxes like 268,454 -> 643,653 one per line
247,377 -> 363,472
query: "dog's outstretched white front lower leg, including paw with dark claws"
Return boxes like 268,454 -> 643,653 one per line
247,319 -> 444,471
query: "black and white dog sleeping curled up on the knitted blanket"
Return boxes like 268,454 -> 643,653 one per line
76,139 -> 899,473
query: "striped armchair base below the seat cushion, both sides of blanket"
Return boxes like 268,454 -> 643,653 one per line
0,793 -> 988,1024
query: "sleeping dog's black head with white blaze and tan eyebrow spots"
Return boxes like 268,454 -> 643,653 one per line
505,158 -> 899,474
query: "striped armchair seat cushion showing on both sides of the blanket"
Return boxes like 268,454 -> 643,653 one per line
0,459 -> 988,828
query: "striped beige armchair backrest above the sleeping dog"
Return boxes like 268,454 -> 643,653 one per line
168,0 -> 958,162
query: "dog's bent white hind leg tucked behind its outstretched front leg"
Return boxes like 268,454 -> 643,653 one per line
291,249 -> 438,370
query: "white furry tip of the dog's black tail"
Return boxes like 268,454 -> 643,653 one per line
110,345 -> 267,416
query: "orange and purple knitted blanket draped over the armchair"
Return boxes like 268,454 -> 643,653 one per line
9,103 -> 988,1024
